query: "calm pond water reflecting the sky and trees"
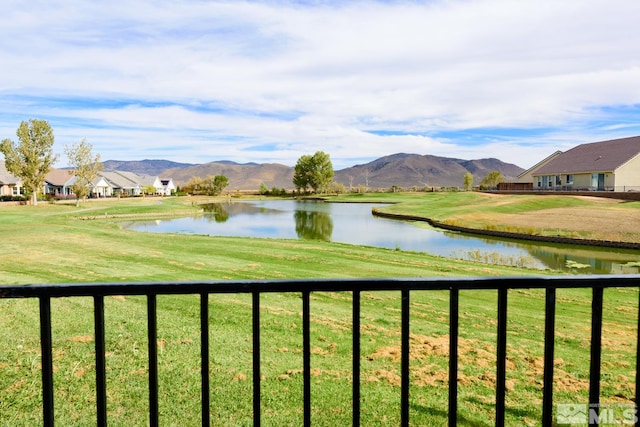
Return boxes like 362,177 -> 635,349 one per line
122,200 -> 640,274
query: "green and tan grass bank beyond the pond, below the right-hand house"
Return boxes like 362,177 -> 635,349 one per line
332,192 -> 640,243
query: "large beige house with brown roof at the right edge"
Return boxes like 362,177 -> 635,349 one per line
527,136 -> 640,191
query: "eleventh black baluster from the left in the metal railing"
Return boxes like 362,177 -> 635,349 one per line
542,288 -> 556,426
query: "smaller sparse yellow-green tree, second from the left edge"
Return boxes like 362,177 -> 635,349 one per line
64,139 -> 104,206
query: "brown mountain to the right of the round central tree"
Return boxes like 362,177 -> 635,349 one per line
335,153 -> 524,189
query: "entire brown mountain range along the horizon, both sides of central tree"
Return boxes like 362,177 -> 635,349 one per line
103,153 -> 524,190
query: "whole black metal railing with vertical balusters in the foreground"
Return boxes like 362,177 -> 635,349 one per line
0,275 -> 640,426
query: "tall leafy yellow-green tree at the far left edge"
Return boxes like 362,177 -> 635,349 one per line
0,119 -> 58,205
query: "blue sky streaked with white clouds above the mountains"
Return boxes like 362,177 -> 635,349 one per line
0,0 -> 640,169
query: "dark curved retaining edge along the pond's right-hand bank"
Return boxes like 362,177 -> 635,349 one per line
371,209 -> 640,249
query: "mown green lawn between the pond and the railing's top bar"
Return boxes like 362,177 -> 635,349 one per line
0,198 -> 537,284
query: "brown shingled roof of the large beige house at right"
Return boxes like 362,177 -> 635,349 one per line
533,136 -> 640,175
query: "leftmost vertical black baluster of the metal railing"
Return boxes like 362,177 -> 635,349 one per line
40,297 -> 54,426
